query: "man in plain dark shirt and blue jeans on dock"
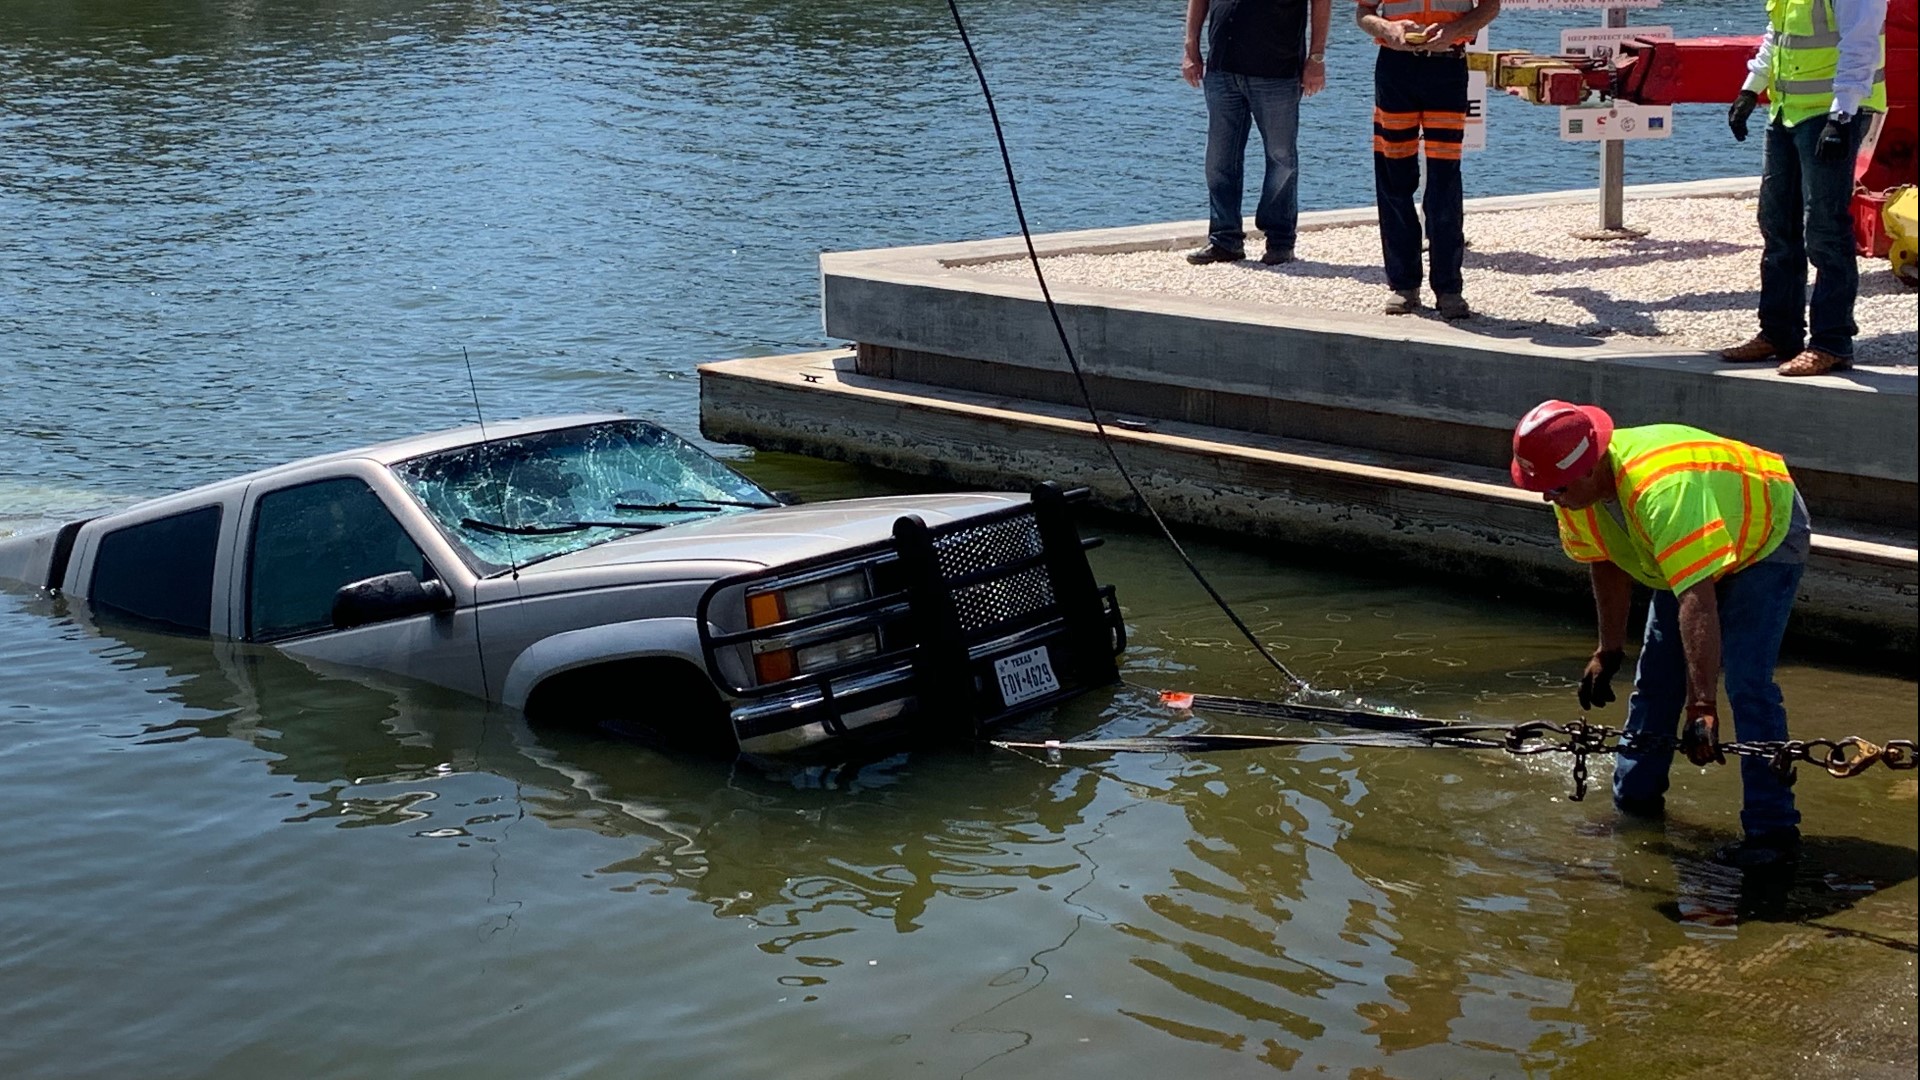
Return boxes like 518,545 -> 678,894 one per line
1181,0 -> 1332,265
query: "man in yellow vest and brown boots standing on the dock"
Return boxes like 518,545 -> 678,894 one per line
1720,0 -> 1887,375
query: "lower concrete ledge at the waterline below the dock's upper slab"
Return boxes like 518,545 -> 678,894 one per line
699,352 -> 1920,659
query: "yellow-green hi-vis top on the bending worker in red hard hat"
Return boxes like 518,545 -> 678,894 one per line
1553,425 -> 1793,592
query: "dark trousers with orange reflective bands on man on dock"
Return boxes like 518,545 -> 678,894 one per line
1373,48 -> 1467,292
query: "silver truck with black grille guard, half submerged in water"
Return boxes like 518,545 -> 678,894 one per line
0,415 -> 1125,753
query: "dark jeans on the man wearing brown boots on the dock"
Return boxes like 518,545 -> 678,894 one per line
1761,113 -> 1872,359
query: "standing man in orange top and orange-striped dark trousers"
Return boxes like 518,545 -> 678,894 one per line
1357,0 -> 1500,319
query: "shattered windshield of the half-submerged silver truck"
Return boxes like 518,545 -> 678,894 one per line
394,421 -> 778,575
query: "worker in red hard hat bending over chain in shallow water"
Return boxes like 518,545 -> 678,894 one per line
1513,402 -> 1812,867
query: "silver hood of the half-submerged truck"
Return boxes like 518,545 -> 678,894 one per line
520,492 -> 1027,577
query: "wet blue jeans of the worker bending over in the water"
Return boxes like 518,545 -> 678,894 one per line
1613,561 -> 1807,836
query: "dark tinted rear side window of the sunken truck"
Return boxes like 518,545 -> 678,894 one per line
86,505 -> 221,634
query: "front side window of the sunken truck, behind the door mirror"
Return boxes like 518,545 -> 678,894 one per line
248,477 -> 434,642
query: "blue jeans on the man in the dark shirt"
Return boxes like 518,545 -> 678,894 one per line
1200,69 -> 1300,252
